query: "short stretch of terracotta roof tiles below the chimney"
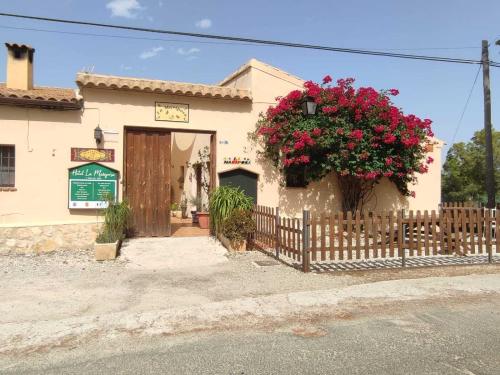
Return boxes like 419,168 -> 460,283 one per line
0,83 -> 81,105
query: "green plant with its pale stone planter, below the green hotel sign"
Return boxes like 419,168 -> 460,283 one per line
94,200 -> 130,260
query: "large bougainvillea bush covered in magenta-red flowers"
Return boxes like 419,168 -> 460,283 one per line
255,76 -> 433,211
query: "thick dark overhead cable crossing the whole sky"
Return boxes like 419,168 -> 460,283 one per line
0,13 -> 500,67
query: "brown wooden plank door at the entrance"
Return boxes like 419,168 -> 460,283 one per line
125,129 -> 171,237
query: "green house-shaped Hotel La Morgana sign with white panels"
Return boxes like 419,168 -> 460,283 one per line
68,163 -> 118,208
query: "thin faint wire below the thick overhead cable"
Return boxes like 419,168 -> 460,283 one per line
0,25 -> 481,51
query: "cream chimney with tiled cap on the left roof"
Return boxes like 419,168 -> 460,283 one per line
5,43 -> 35,90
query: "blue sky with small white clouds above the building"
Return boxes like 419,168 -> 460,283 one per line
0,0 -> 500,156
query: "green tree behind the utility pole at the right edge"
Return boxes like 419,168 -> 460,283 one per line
442,130 -> 500,203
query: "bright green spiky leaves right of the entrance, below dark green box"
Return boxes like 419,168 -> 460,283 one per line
209,186 -> 253,233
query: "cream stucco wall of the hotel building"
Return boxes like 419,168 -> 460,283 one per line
0,62 -> 441,231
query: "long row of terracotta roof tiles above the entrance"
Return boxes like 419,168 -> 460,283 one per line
76,73 -> 252,100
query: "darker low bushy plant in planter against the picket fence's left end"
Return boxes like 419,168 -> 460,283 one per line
220,209 -> 255,251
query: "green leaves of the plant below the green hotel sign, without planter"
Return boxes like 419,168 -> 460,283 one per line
96,200 -> 131,243
